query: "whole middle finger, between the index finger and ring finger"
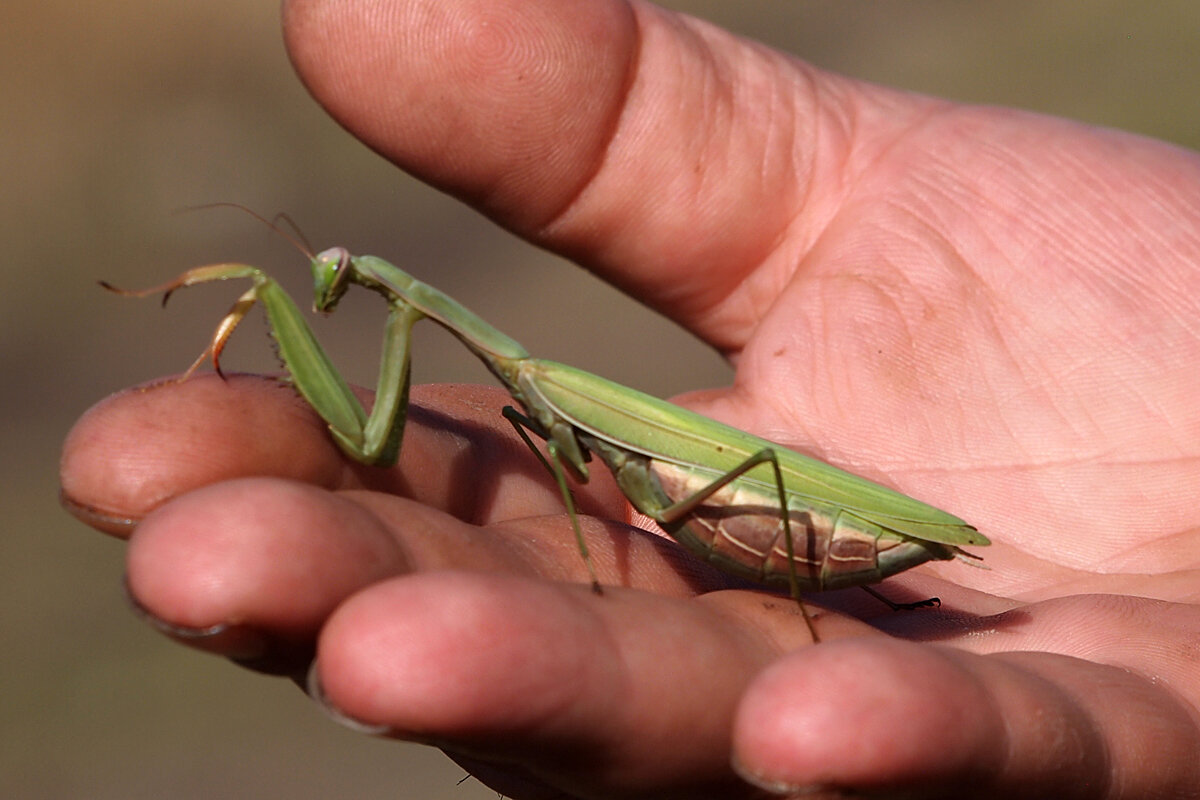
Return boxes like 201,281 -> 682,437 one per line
126,477 -> 638,670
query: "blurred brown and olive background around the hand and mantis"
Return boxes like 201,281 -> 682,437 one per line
0,0 -> 1200,800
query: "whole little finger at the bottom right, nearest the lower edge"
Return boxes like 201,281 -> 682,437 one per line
733,638 -> 1200,800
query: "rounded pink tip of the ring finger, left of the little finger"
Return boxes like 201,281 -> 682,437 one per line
318,571 -> 597,746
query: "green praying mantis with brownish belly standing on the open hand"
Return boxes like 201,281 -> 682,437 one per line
102,215 -> 990,642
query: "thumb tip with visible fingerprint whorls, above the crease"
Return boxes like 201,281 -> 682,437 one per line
283,0 -> 637,228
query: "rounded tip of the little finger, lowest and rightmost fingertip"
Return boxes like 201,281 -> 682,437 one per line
733,637 -> 1003,790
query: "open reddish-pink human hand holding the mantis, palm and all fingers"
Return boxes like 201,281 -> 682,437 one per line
62,0 -> 1200,799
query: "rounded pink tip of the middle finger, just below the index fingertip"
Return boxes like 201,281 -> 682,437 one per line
127,479 -> 406,639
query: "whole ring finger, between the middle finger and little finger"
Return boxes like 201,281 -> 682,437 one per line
317,572 -> 803,796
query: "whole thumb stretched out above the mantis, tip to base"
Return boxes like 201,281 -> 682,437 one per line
284,0 -> 928,338
